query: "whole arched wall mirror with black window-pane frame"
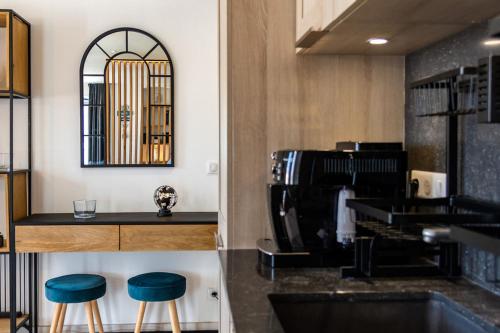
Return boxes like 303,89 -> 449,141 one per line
80,28 -> 174,167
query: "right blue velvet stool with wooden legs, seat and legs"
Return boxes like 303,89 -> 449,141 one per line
128,272 -> 186,333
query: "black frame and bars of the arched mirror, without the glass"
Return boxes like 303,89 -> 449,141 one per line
80,27 -> 175,168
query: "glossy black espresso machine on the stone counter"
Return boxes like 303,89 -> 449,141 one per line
257,142 -> 407,267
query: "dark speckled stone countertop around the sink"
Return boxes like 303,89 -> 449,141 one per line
219,250 -> 500,333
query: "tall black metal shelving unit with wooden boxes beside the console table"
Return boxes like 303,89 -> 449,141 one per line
0,9 -> 38,333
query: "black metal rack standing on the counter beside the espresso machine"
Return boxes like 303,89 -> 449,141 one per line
341,197 -> 500,278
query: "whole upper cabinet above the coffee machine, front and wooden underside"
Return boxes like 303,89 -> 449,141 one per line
296,0 -> 500,55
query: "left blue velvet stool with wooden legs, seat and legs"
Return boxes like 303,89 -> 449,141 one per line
45,274 -> 106,333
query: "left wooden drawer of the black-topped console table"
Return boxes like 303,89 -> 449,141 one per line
16,225 -> 120,252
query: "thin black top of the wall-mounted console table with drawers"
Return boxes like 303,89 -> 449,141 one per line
16,212 -> 217,226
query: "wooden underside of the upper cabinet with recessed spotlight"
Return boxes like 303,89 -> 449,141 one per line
299,0 -> 500,55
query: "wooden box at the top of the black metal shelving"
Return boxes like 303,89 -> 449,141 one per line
0,10 -> 29,97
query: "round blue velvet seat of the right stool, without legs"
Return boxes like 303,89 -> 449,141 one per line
128,272 -> 186,302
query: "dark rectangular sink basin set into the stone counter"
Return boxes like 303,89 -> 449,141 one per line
268,293 -> 500,333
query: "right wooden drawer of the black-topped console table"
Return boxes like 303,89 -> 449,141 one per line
120,224 -> 217,251
